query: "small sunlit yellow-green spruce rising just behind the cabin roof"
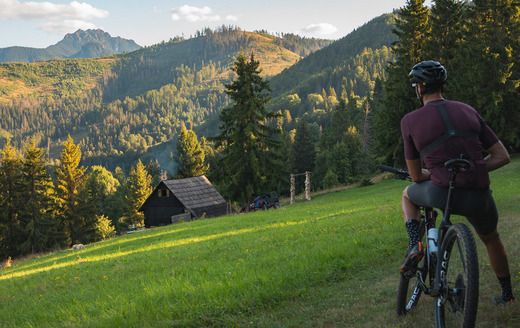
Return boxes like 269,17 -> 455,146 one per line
177,123 -> 208,178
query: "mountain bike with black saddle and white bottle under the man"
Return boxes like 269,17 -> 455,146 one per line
380,159 -> 479,328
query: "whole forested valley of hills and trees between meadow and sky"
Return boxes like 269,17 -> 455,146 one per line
0,0 -> 520,257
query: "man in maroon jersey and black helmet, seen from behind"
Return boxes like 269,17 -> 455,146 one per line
401,60 -> 514,304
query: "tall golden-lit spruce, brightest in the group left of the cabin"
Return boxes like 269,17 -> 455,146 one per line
56,135 -> 85,244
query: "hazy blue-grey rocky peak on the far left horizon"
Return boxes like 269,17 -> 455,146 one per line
0,29 -> 141,62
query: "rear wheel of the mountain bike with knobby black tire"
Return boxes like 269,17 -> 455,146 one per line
435,223 -> 479,328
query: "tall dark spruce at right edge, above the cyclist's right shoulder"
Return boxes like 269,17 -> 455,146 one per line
460,0 -> 520,148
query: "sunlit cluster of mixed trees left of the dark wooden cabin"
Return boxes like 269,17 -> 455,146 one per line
0,136 -> 152,258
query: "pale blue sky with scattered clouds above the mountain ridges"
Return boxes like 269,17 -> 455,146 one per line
0,0 -> 429,48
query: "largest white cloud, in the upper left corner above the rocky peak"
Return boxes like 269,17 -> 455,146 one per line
0,0 -> 109,33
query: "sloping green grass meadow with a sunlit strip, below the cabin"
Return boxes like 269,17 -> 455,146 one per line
0,158 -> 520,327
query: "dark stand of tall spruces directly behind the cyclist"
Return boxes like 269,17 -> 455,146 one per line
375,0 -> 520,162
